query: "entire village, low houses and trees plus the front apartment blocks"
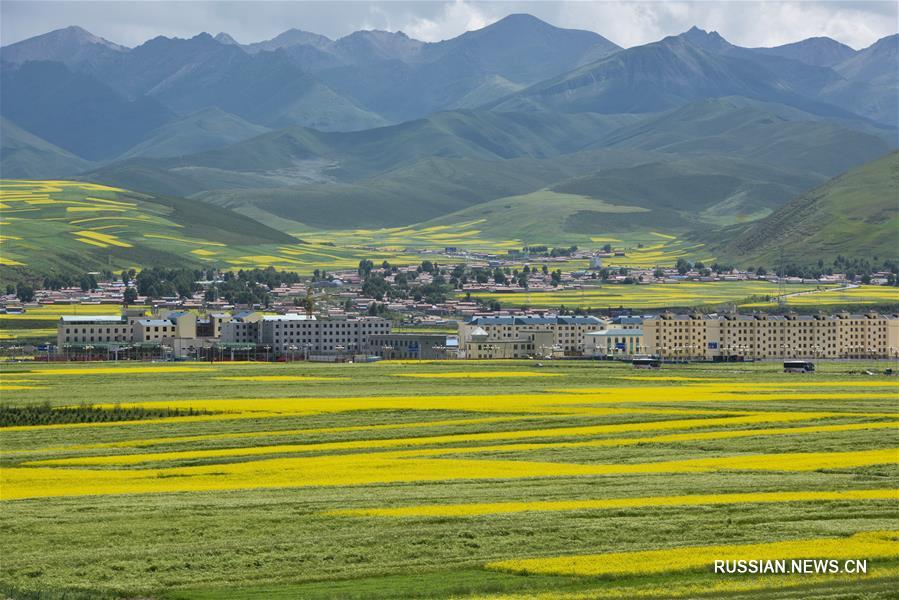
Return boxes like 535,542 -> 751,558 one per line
0,249 -> 899,362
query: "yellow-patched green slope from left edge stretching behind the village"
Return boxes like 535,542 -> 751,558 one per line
0,180 -> 728,280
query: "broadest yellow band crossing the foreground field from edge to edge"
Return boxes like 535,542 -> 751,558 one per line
0,448 -> 899,501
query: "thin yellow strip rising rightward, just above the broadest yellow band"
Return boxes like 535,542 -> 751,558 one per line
17,413 -> 856,466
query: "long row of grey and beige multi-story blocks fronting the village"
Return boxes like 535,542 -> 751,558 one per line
57,311 -> 899,361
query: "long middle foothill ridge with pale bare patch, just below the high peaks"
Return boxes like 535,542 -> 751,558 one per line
86,111 -> 640,196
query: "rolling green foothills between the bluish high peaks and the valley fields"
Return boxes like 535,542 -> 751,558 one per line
85,98 -> 893,231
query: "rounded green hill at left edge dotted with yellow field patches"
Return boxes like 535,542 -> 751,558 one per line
0,179 -> 296,281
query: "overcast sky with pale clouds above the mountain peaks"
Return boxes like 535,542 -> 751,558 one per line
0,0 -> 899,48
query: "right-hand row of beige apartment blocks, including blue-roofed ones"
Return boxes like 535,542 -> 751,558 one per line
459,313 -> 899,361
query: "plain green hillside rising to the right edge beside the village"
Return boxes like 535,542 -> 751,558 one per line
716,152 -> 899,264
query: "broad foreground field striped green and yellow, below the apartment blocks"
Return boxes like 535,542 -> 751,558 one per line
0,361 -> 899,599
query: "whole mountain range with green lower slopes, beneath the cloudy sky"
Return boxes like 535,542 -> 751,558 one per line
0,15 -> 899,264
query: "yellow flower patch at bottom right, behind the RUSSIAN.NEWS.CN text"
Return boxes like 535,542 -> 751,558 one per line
487,531 -> 899,577
